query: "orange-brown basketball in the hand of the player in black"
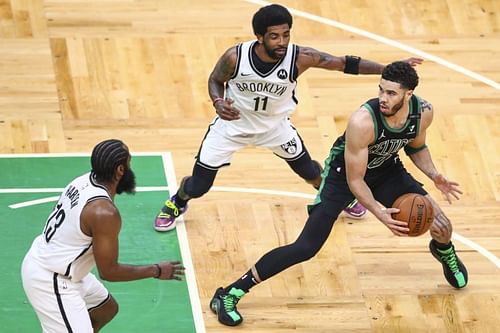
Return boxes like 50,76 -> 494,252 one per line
392,193 -> 434,237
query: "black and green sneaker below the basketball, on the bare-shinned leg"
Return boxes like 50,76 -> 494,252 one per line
429,239 -> 469,289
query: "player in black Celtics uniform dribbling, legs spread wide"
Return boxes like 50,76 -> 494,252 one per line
210,62 -> 468,326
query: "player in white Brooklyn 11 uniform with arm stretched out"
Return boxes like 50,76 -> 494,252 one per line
154,5 -> 422,231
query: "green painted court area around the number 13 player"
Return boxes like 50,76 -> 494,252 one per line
0,155 -> 199,333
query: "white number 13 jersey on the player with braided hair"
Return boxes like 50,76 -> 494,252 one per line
28,173 -> 111,281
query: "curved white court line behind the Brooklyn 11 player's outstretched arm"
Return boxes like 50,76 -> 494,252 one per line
243,0 -> 500,90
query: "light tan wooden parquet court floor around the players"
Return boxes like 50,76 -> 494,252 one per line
0,0 -> 500,333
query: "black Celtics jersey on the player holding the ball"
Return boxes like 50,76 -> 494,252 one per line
329,95 -> 422,177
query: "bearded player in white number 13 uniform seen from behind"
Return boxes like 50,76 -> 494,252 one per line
22,140 -> 184,333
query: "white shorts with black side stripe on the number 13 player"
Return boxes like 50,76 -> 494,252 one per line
21,254 -> 109,333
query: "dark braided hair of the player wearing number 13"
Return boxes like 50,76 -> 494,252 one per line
90,139 -> 130,182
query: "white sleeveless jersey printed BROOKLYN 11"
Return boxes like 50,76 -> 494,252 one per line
225,41 -> 298,135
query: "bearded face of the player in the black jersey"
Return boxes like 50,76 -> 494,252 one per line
378,79 -> 411,117
